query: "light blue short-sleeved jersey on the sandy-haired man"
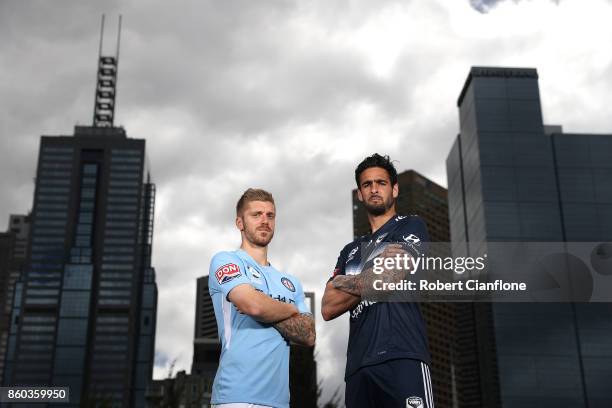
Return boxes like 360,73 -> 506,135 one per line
208,250 -> 310,408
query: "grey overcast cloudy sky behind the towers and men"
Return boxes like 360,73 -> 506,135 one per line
0,0 -> 612,404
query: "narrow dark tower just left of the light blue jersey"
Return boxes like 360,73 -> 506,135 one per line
191,275 -> 221,378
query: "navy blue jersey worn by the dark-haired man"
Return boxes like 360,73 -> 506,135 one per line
334,215 -> 431,378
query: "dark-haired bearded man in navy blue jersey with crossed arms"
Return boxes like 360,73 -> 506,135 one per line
321,154 -> 434,408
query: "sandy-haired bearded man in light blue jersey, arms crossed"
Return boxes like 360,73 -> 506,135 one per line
209,189 -> 315,408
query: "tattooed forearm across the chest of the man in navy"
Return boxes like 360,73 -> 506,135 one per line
331,244 -> 410,298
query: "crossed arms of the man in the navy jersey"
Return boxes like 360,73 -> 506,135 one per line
321,244 -> 409,321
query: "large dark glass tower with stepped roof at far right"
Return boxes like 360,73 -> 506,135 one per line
446,67 -> 612,407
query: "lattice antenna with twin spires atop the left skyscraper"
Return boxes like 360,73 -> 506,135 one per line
93,14 -> 121,127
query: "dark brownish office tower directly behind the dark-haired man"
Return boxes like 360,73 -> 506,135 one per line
353,170 -> 456,408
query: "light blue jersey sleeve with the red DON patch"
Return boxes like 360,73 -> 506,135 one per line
208,252 -> 251,299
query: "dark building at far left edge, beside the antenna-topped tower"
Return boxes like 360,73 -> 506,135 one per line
0,215 -> 30,384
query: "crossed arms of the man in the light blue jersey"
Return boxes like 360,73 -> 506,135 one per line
228,284 -> 316,347
